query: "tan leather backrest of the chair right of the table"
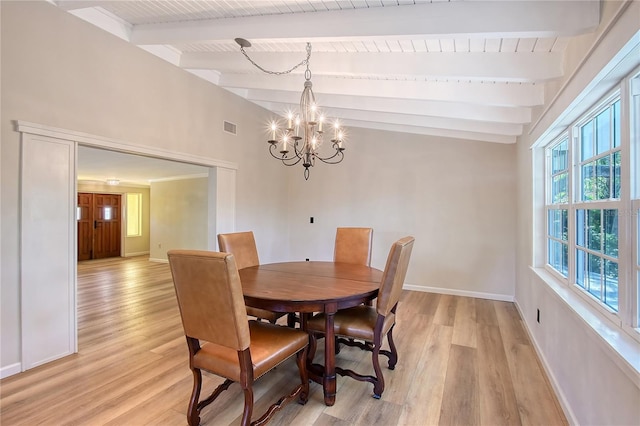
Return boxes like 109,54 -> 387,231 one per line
376,237 -> 415,316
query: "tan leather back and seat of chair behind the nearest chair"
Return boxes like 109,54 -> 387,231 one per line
218,231 -> 292,325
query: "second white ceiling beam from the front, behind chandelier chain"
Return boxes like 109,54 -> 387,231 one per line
180,48 -> 562,83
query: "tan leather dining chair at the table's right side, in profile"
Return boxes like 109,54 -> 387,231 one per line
306,237 -> 415,399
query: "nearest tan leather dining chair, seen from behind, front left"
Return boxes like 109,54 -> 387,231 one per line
167,250 -> 309,426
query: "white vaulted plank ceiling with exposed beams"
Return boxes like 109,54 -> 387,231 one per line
53,0 -> 600,143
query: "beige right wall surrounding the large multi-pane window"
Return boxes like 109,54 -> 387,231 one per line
515,1 -> 640,425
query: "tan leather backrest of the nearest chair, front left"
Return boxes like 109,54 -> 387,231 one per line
167,250 -> 250,351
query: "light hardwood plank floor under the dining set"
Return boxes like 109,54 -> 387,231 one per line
0,257 -> 567,426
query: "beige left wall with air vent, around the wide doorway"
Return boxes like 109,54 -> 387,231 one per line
0,1 -> 288,371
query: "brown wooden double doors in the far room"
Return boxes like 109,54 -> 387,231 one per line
78,193 -> 121,260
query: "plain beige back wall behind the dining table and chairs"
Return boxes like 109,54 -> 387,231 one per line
289,126 -> 516,300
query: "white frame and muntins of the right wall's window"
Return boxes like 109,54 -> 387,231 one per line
541,68 -> 640,341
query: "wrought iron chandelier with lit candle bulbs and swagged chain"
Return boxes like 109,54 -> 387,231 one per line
235,38 -> 345,180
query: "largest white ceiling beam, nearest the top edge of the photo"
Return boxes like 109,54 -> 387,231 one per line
131,1 -> 600,44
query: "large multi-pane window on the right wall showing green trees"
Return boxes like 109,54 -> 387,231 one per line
545,70 -> 640,339
